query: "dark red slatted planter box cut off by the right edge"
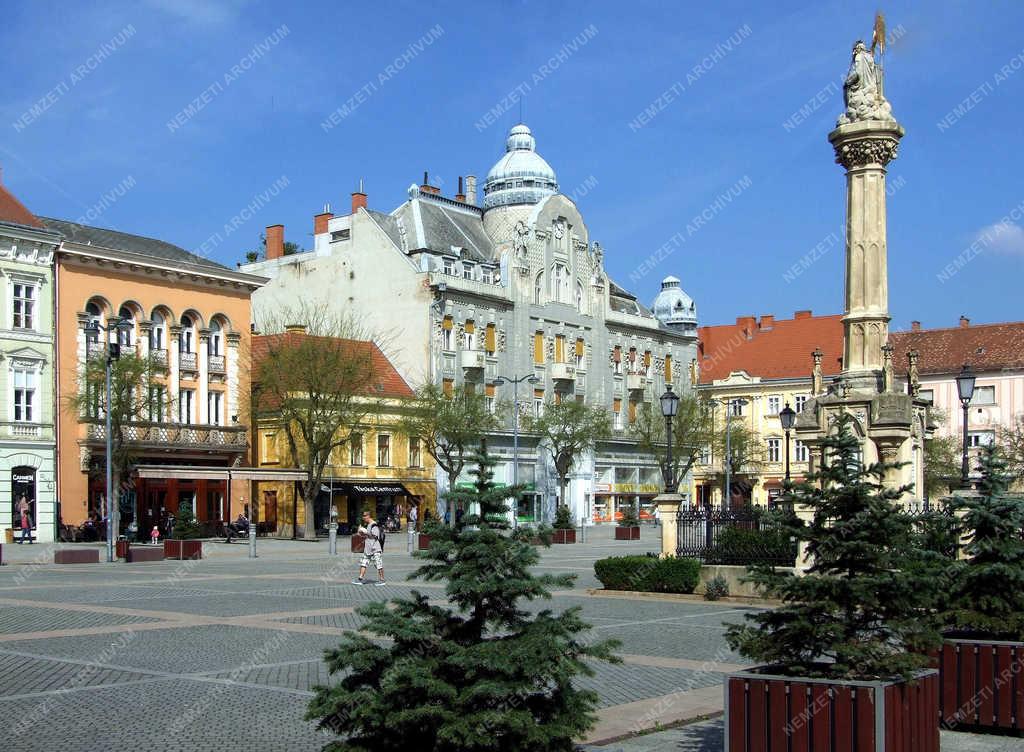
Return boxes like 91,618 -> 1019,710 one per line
938,637 -> 1024,732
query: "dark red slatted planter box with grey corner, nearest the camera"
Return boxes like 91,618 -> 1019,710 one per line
725,669 -> 939,752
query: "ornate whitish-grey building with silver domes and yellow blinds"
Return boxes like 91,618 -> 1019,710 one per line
243,124 -> 697,521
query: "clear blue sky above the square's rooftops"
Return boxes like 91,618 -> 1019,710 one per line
0,0 -> 1024,329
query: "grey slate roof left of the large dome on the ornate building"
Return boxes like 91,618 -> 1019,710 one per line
394,198 -> 494,261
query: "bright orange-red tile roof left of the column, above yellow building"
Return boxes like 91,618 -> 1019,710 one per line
697,310 -> 843,384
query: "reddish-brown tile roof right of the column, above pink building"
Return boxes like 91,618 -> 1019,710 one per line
889,322 -> 1024,374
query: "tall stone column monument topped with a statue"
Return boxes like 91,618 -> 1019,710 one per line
796,42 -> 930,500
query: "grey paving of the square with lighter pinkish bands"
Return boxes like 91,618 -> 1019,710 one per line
0,529 -> 1024,752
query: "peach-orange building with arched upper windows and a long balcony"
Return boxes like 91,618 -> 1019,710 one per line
47,217 -> 265,531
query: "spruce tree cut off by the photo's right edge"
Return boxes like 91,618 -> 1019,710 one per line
943,447 -> 1024,640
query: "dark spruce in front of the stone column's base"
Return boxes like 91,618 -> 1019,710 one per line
726,418 -> 938,679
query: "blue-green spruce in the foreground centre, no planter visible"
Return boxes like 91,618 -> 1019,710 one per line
306,449 -> 618,752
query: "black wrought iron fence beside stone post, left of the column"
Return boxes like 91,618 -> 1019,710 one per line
676,505 -> 797,567
